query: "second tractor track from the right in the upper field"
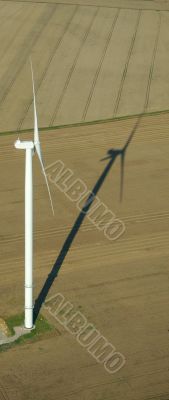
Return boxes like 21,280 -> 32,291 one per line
113,10 -> 142,117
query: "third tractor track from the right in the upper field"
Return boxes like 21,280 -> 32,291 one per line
82,9 -> 120,121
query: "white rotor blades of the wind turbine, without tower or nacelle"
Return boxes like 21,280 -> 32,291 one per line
30,59 -> 54,215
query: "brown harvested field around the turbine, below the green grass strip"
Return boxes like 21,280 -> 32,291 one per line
0,113 -> 169,400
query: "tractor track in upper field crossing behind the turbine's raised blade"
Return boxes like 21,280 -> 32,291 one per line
18,6 -> 79,130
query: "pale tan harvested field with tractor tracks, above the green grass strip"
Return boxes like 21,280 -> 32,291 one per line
0,0 -> 169,131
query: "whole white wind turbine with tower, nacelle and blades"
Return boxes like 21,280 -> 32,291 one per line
15,61 -> 54,329
